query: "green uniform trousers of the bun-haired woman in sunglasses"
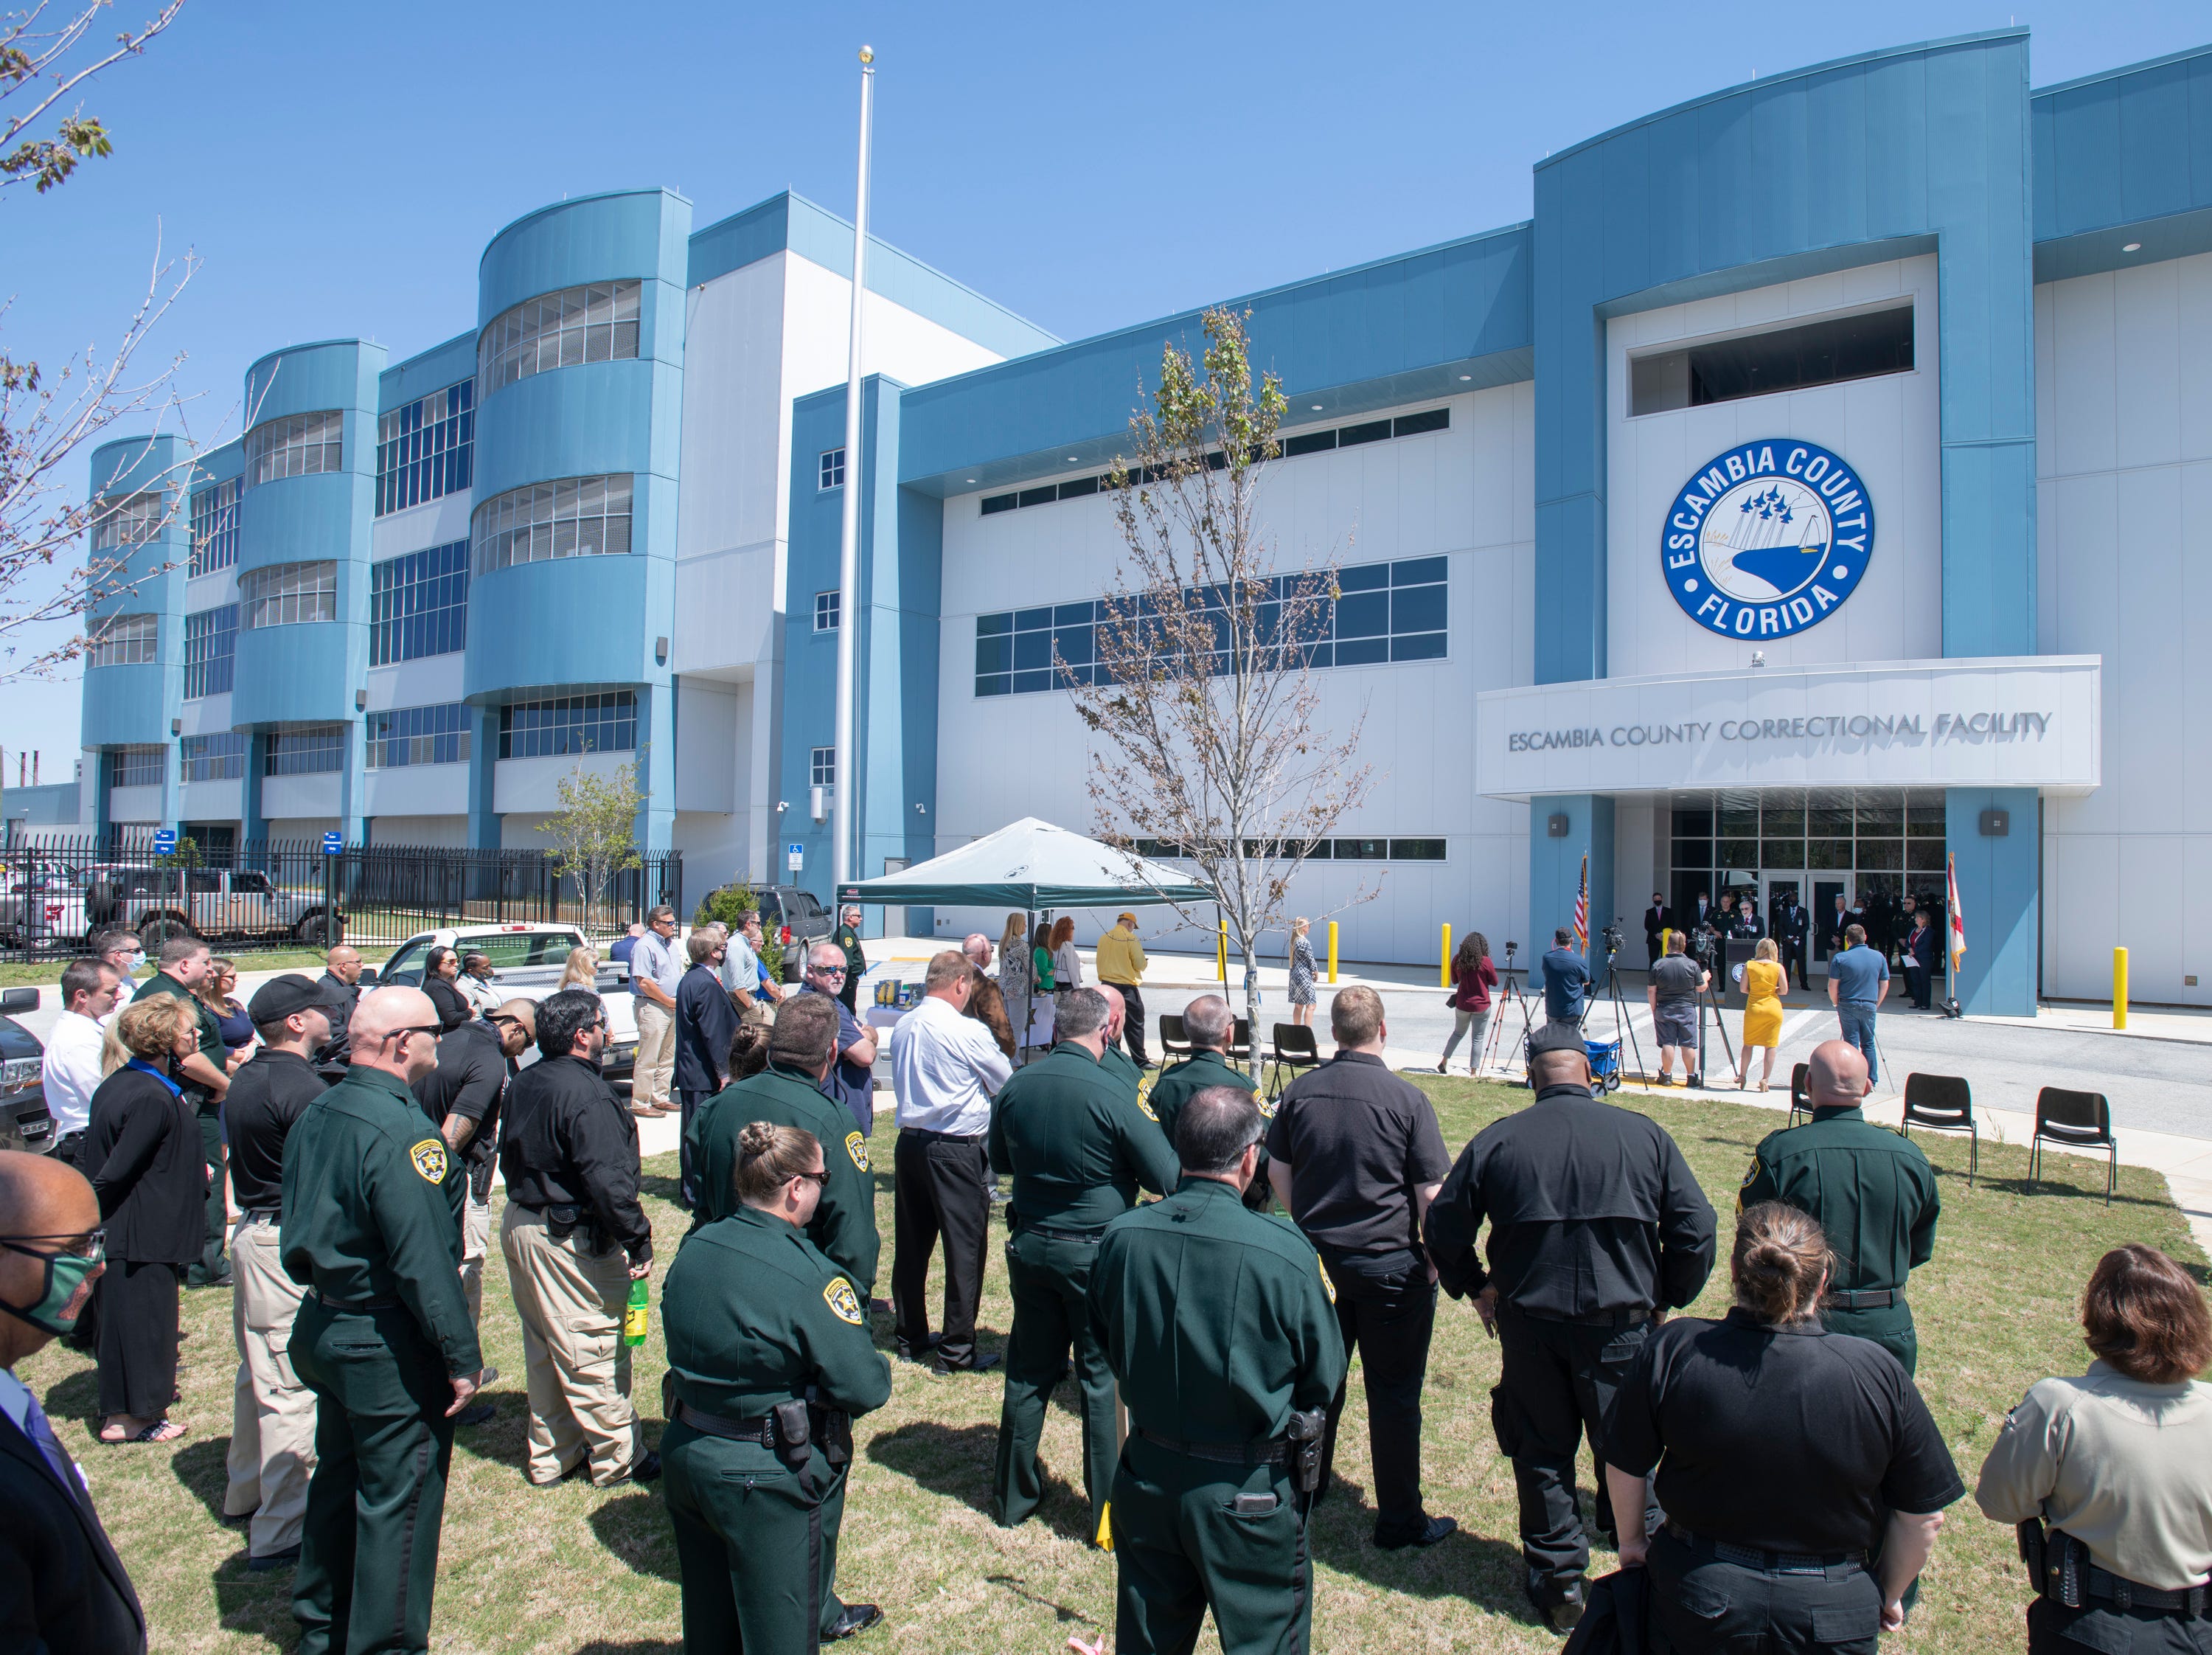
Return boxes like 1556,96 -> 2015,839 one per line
661,1420 -> 845,1655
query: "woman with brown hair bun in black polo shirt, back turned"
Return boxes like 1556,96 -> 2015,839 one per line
1604,1201 -> 1966,1655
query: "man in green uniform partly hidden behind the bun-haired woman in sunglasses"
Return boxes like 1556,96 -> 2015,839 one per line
686,993 -> 883,1637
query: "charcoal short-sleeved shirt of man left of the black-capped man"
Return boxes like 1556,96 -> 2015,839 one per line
1267,1051 -> 1451,1255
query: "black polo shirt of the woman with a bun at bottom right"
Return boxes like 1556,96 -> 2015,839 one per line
1604,1310 -> 1966,1553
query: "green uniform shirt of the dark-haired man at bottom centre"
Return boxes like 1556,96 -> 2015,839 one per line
1091,1177 -> 1345,1434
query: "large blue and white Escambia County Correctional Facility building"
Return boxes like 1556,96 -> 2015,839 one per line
82,29 -> 2212,1013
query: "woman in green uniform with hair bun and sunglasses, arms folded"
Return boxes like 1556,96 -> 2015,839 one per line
661,1120 -> 891,1655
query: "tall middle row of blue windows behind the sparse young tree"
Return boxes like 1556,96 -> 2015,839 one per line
975,558 -> 1451,695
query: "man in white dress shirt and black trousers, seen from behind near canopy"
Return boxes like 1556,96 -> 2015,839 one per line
891,949 -> 1013,1372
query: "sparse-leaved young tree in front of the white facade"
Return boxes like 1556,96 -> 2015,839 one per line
1057,308 -> 1376,1024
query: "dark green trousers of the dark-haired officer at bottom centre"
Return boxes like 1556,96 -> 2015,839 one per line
1113,1436 -> 1314,1655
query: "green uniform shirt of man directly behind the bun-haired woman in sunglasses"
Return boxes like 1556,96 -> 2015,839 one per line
686,1064 -> 883,1310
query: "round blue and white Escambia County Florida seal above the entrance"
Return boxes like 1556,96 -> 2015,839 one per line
1659,436 -> 1874,639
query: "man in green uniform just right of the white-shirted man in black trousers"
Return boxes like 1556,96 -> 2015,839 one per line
984,989 -> 1177,1536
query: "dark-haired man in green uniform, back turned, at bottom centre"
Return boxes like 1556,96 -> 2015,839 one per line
1088,1086 -> 1345,1655
